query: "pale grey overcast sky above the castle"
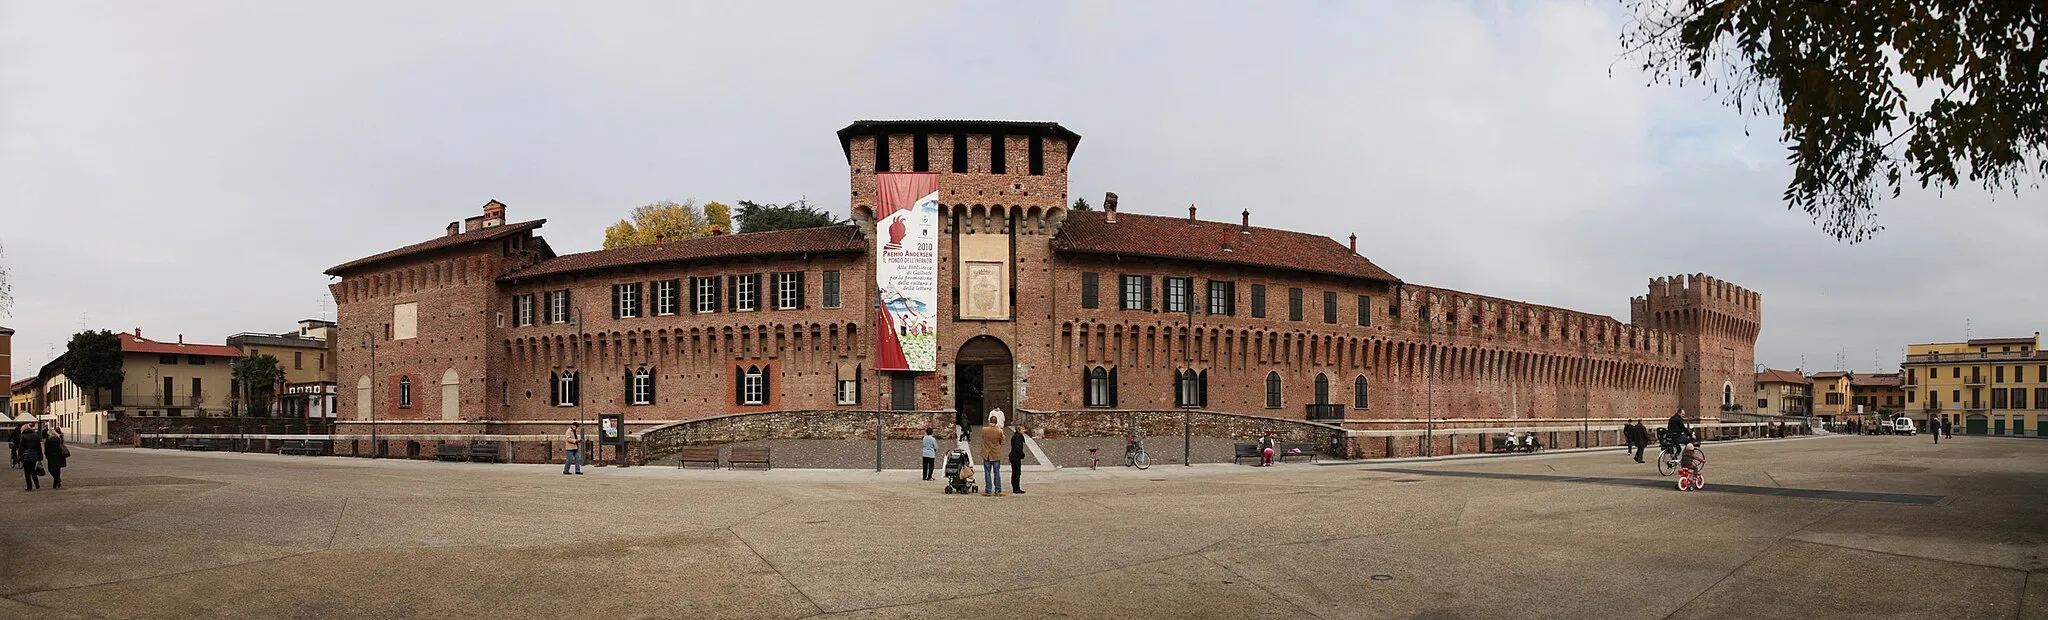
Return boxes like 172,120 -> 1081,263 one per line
0,0 -> 2048,377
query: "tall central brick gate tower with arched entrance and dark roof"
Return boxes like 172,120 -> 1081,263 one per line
840,121 -> 1081,424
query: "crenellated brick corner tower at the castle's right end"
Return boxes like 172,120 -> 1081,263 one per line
1630,274 -> 1763,419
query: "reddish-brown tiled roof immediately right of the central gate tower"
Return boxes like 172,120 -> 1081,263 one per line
1053,211 -> 1401,284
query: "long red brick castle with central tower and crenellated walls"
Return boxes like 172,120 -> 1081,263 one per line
330,121 -> 1761,441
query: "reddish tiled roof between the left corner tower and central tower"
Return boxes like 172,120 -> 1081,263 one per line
509,225 -> 868,282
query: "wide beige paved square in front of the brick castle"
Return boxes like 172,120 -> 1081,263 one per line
0,436 -> 2048,618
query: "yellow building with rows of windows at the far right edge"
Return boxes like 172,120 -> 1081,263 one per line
1901,331 -> 2048,436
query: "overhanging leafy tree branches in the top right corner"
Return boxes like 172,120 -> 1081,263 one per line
1622,0 -> 2048,243
